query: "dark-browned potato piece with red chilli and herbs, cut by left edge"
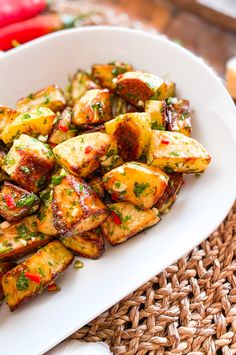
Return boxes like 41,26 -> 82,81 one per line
0,182 -> 40,222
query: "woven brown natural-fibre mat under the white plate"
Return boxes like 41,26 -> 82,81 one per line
51,0 -> 236,355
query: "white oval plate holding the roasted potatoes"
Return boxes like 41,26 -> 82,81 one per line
0,27 -> 236,355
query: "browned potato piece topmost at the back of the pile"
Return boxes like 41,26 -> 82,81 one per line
92,61 -> 133,89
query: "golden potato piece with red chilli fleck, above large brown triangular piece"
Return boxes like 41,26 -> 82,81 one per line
53,132 -> 111,178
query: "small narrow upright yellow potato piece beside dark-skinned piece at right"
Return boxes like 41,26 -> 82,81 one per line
145,100 -> 167,131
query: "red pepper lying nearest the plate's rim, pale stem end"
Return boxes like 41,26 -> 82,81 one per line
0,13 -> 75,51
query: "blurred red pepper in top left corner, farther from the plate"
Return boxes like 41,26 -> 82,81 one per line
0,0 -> 47,28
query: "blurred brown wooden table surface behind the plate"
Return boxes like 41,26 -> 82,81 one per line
94,0 -> 236,76
